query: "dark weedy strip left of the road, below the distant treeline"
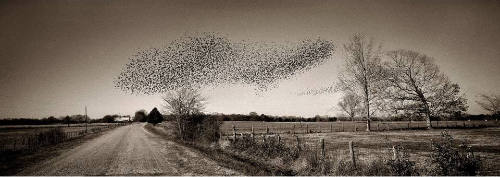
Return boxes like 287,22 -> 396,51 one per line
0,123 -> 128,152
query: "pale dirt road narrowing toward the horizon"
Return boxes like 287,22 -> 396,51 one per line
18,124 -> 240,176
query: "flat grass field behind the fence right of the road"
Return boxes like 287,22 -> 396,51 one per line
221,121 -> 500,175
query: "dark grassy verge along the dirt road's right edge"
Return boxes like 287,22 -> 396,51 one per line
145,124 -> 292,176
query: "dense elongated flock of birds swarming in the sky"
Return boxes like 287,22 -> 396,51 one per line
115,33 -> 335,94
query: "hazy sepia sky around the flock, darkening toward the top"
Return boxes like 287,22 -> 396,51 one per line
0,0 -> 500,118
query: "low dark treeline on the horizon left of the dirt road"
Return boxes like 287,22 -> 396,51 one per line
0,114 -> 128,125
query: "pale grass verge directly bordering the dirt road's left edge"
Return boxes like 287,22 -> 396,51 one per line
0,126 -> 125,176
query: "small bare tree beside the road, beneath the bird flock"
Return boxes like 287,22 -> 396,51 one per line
163,88 -> 206,140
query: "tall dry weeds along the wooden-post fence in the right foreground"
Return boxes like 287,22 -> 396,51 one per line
226,130 -> 489,176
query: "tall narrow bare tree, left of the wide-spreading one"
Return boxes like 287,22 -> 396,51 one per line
337,34 -> 383,131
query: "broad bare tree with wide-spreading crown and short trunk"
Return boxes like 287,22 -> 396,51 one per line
385,50 -> 467,129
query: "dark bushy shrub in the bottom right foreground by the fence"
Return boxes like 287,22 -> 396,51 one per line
431,131 -> 481,176
